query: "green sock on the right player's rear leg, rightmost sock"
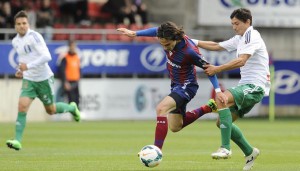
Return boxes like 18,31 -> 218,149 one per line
231,124 -> 253,156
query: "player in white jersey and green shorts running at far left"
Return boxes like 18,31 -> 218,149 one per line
6,11 -> 80,150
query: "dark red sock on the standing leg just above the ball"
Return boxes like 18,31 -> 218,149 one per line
154,116 -> 168,149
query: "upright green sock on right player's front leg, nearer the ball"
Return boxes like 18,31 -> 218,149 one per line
219,108 -> 232,150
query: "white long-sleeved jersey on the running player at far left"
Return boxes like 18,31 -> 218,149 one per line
12,29 -> 53,82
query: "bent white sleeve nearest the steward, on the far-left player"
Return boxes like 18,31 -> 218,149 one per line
27,32 -> 51,69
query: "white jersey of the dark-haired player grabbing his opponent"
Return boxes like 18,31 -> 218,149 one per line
219,26 -> 270,95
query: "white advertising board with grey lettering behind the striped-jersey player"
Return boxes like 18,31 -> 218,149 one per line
54,78 -> 257,120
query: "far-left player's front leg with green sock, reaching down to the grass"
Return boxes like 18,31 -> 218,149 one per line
6,79 -> 36,150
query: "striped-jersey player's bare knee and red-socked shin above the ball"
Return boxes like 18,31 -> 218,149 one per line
154,96 -> 176,149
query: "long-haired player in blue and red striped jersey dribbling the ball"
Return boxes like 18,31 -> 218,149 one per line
117,22 -> 227,148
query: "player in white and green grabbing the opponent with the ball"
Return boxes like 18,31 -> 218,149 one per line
194,8 -> 270,170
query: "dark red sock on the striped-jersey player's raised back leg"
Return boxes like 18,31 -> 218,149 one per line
182,105 -> 207,128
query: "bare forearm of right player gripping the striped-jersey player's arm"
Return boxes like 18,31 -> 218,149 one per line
204,54 -> 251,76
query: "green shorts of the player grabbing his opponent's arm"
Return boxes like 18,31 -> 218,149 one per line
228,84 -> 264,118
